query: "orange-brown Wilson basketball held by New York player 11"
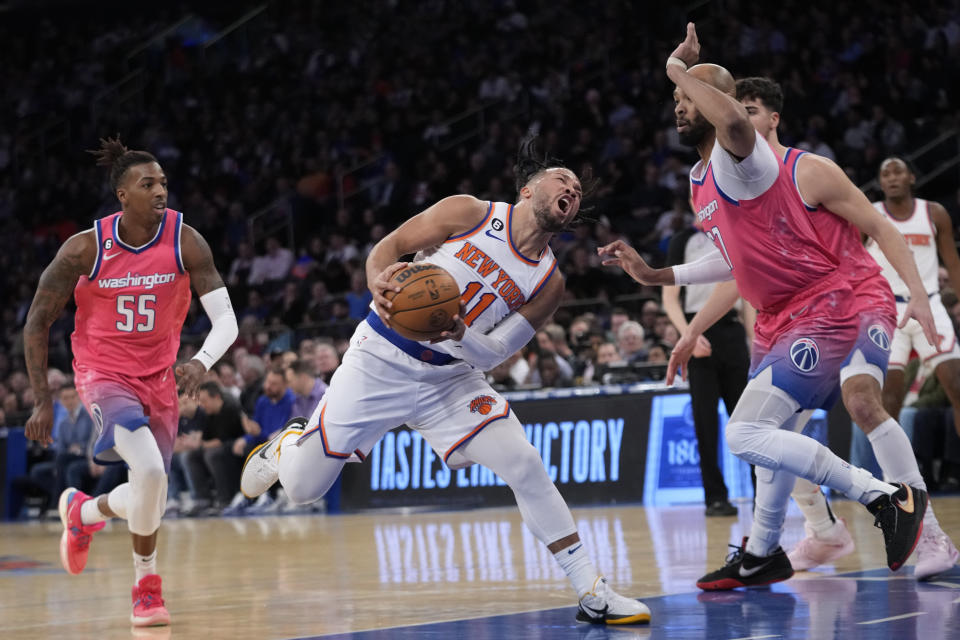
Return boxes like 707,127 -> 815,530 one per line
386,262 -> 460,341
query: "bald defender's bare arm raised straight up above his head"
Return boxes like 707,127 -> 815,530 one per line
667,22 -> 757,158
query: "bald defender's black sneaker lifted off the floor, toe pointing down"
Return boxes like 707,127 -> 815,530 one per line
867,482 -> 927,571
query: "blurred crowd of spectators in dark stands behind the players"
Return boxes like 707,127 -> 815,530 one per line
0,0 -> 960,508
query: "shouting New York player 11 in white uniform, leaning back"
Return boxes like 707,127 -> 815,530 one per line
240,134 -> 650,624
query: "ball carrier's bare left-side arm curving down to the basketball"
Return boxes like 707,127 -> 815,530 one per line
366,195 -> 490,327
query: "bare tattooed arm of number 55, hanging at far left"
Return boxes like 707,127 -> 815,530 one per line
23,231 -> 97,444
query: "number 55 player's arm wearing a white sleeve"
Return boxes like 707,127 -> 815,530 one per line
176,225 -> 239,396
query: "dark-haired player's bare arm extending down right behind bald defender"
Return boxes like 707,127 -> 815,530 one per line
797,153 -> 939,345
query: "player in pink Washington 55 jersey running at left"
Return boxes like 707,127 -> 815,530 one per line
23,139 -> 237,626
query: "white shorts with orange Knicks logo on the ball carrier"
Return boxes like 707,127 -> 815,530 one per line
301,320 -> 516,469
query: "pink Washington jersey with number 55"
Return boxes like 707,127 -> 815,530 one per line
72,209 -> 190,377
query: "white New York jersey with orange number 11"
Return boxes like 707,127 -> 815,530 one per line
416,202 -> 560,356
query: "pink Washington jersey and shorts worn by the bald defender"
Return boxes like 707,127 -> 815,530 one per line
690,134 -> 858,408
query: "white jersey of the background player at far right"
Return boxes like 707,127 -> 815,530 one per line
866,198 -> 940,298
